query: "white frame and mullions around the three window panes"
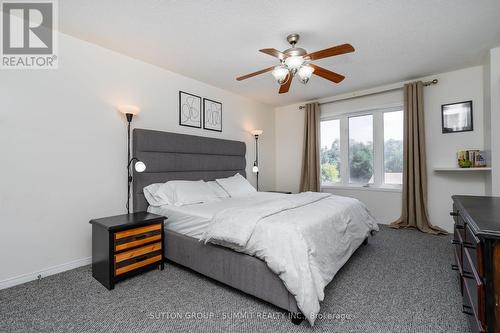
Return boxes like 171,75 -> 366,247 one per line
320,104 -> 403,192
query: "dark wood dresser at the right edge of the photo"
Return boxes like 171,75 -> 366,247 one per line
450,195 -> 500,333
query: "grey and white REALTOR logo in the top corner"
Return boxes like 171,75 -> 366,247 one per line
1,1 -> 57,69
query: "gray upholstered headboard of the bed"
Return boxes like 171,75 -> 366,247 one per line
132,128 -> 246,212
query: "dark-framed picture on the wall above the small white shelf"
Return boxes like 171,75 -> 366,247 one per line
441,101 -> 474,133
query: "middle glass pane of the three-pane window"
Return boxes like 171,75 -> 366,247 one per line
349,114 -> 373,184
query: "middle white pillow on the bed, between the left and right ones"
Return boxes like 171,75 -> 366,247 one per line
170,180 -> 219,206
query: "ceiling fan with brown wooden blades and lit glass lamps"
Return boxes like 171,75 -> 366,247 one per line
236,34 -> 354,94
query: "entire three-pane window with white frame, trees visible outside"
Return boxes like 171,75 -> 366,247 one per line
320,107 -> 403,188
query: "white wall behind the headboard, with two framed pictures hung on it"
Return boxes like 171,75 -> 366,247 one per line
0,35 -> 275,286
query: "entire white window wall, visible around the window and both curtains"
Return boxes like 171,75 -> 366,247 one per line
275,66 -> 485,231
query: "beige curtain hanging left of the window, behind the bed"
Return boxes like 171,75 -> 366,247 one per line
300,103 -> 320,192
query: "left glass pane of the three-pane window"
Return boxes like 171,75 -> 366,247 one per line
320,119 -> 340,184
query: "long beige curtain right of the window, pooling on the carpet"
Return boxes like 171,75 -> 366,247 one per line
391,81 -> 446,234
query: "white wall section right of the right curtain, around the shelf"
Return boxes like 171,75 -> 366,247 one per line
424,66 -> 486,231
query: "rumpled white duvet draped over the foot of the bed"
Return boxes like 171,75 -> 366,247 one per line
203,192 -> 378,325
